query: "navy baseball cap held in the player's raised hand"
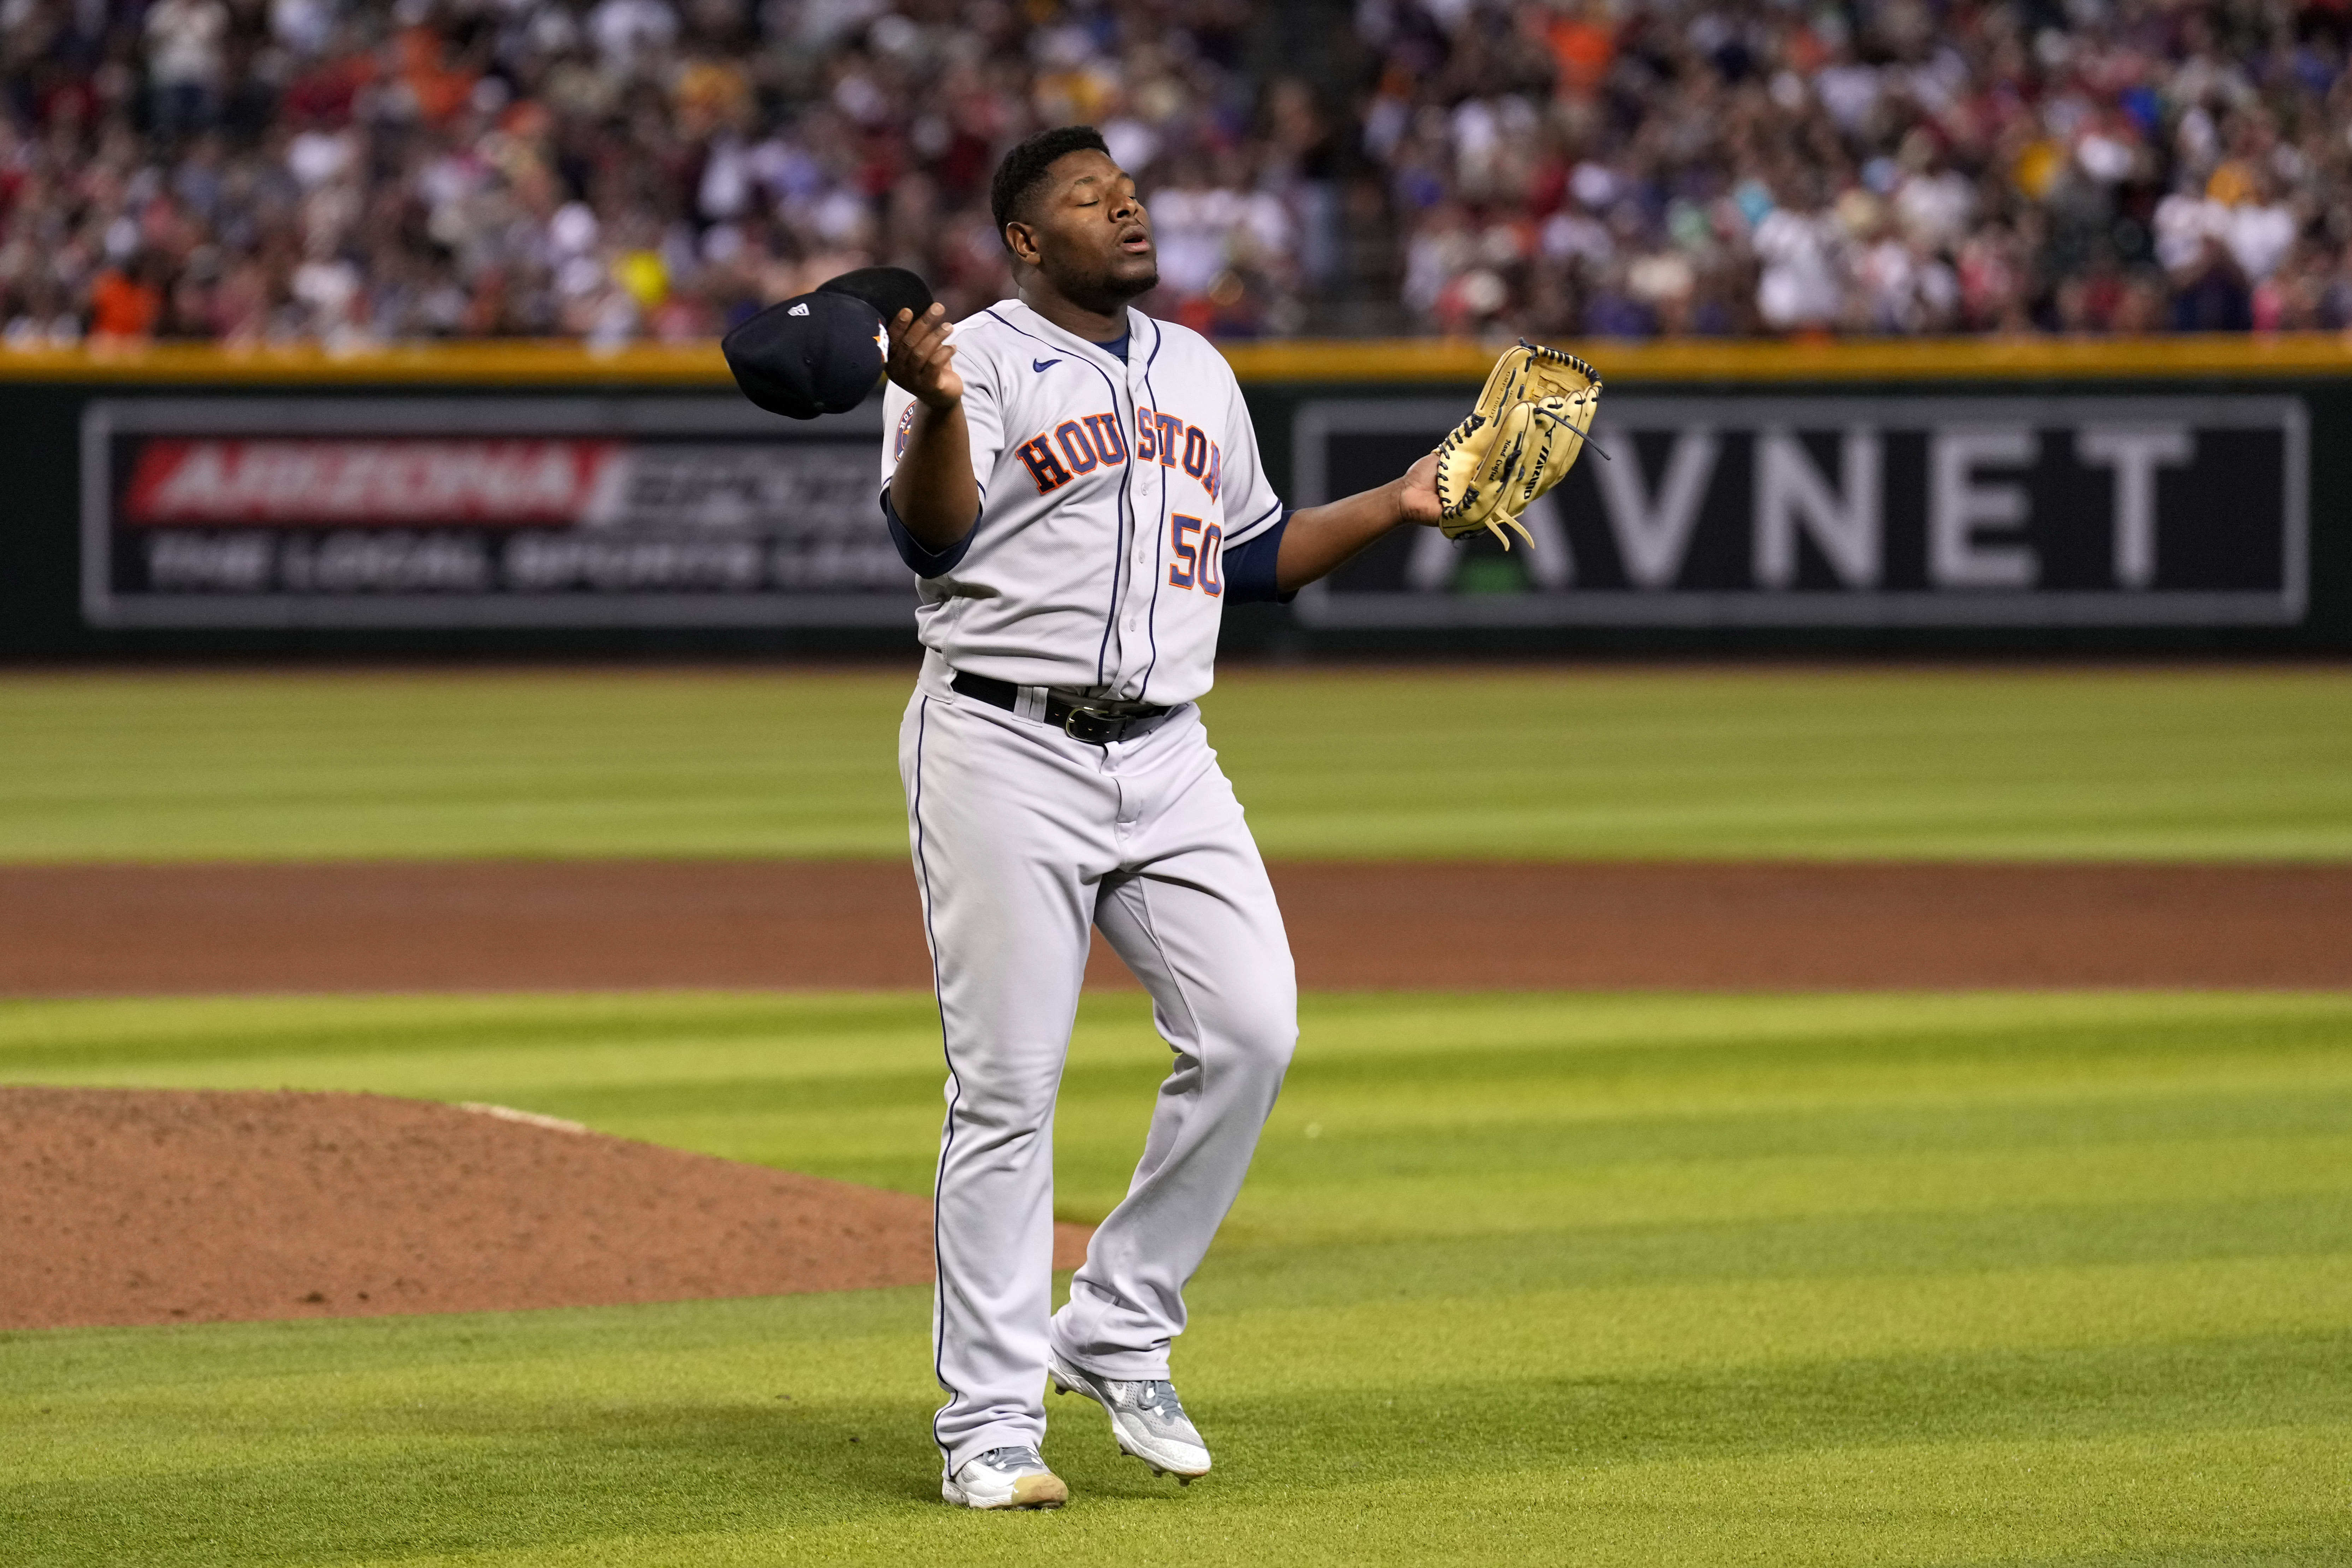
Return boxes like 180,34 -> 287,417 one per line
720,266 -> 931,419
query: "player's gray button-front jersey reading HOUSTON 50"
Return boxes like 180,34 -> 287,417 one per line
882,301 -> 1282,703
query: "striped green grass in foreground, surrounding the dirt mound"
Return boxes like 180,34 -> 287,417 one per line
0,994 -> 2352,1568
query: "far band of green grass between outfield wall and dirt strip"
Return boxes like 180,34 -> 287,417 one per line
0,668 -> 2352,860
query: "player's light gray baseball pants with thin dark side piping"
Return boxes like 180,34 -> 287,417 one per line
899,653 -> 1298,1474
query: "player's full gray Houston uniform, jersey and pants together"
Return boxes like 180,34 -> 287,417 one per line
882,301 -> 1298,1474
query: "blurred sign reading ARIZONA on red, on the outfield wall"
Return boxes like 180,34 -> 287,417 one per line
82,395 -> 913,628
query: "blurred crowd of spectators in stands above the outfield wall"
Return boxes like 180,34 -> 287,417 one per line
0,0 -> 2352,345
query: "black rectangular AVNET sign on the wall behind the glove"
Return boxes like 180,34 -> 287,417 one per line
1293,395 -> 2307,625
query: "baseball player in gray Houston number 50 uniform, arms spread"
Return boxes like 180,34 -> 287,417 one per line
729,127 -> 1599,1509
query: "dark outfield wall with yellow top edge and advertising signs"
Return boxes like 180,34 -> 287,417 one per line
0,336 -> 2352,658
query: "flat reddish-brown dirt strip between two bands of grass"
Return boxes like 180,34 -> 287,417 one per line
0,860 -> 2352,997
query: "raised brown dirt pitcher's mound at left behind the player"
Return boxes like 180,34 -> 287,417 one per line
0,1088 -> 1086,1328
